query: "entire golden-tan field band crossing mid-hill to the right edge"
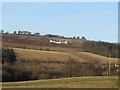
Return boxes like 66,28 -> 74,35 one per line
14,48 -> 118,64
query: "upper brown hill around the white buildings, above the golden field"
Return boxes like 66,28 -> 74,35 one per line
2,34 -> 119,58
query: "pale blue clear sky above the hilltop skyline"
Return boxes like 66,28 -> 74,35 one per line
0,2 -> 118,42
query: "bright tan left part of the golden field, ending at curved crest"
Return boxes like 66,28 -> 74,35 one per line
14,48 -> 80,61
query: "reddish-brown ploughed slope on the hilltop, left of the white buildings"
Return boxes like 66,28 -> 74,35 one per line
2,34 -> 54,45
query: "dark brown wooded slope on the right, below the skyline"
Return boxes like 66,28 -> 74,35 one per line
81,41 -> 120,58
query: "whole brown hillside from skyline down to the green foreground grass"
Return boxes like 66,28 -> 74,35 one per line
2,34 -> 118,82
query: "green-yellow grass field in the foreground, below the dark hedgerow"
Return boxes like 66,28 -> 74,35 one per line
2,76 -> 118,88
